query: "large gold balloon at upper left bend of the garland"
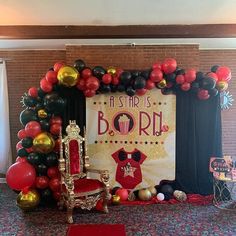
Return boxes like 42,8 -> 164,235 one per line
57,66 -> 79,87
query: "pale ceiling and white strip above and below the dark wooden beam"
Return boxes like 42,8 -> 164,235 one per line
0,0 -> 236,50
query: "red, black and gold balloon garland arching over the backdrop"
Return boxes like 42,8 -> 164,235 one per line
6,58 -> 231,210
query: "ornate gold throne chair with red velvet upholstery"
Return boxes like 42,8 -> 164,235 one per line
58,121 -> 110,223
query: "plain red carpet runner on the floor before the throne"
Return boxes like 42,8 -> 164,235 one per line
67,224 -> 126,236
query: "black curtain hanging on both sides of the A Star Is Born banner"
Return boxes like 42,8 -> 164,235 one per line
59,87 -> 222,195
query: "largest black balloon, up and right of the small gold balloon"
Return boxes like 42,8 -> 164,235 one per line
44,92 -> 65,114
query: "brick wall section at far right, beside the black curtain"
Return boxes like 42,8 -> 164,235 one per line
199,50 -> 236,156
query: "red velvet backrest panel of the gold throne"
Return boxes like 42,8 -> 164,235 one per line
69,140 -> 80,175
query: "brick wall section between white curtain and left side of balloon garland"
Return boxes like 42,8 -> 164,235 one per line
0,50 -> 65,161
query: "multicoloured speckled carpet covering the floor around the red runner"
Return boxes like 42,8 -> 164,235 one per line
0,184 -> 236,236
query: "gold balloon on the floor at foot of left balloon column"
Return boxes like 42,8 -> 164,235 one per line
16,190 -> 40,211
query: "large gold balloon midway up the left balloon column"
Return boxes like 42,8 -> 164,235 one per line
33,132 -> 55,153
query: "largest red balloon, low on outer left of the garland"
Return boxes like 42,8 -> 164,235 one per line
6,161 -> 36,191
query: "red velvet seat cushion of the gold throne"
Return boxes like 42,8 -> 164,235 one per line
63,179 -> 104,193
